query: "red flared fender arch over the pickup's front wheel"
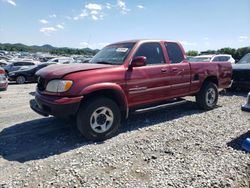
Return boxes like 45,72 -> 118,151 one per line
80,82 -> 129,118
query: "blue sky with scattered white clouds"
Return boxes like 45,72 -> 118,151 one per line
0,0 -> 250,51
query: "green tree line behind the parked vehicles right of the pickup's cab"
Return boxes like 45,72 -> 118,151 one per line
186,47 -> 250,61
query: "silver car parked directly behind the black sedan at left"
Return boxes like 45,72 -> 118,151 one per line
3,61 -> 36,74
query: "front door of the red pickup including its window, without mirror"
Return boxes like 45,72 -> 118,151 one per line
126,42 -> 170,106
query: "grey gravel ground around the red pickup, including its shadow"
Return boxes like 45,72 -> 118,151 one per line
0,84 -> 250,188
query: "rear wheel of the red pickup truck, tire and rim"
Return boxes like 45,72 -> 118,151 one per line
196,82 -> 219,110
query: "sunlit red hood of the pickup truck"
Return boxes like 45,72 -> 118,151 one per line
36,63 -> 114,79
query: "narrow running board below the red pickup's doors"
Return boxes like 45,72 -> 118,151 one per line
132,99 -> 187,114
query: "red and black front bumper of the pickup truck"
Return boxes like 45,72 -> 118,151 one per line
30,92 -> 83,117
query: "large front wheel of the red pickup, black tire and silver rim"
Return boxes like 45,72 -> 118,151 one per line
76,97 -> 121,141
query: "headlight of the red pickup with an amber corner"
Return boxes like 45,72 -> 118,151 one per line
46,80 -> 73,93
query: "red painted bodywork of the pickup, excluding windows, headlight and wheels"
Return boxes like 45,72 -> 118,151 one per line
33,40 -> 232,117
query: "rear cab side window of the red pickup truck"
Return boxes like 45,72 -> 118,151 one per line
165,42 -> 184,64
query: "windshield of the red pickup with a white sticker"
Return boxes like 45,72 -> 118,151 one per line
90,43 -> 135,65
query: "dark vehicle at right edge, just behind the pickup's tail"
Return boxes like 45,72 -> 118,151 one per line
232,53 -> 250,89
